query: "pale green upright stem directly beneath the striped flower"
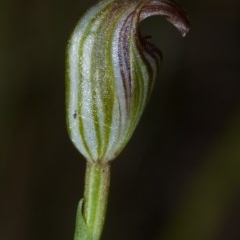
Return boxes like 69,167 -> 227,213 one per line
83,163 -> 110,240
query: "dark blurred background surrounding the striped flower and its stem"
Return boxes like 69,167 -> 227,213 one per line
0,0 -> 240,240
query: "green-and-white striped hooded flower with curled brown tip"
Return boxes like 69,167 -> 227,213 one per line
67,0 -> 189,162
